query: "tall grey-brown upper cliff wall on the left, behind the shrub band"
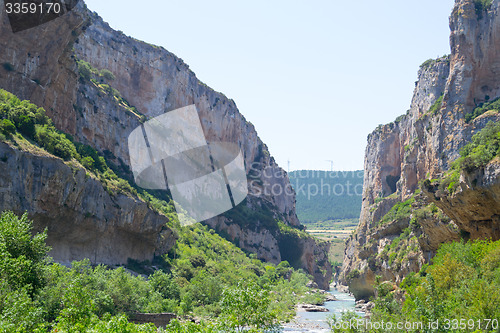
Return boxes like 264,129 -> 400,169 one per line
0,0 -> 331,288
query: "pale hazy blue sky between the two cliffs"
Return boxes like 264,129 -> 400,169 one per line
86,0 -> 454,170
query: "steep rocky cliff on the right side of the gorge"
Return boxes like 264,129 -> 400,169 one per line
339,0 -> 500,298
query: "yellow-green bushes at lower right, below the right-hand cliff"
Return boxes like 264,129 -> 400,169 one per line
372,241 -> 500,332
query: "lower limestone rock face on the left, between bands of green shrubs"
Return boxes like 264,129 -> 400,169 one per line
0,143 -> 175,265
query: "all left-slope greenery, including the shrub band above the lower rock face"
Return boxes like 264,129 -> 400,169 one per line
0,89 -> 324,332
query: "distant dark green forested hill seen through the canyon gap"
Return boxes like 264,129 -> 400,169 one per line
288,170 -> 364,223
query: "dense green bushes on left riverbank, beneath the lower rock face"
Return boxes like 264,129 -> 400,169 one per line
0,212 -> 324,332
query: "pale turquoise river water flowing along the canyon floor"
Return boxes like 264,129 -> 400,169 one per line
284,289 -> 363,333
